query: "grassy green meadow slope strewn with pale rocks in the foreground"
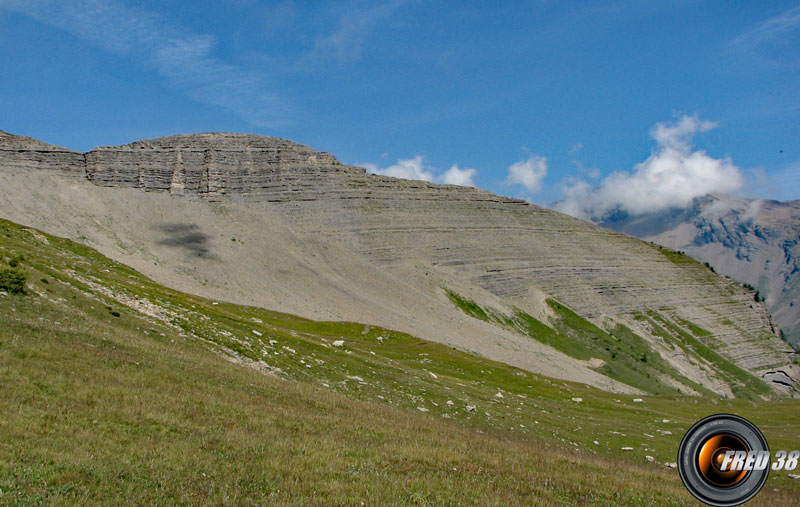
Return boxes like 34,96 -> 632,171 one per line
0,222 -> 800,505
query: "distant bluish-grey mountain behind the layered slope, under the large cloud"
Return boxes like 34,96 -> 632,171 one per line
597,195 -> 800,348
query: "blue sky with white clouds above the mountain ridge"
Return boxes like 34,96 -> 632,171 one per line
0,0 -> 800,215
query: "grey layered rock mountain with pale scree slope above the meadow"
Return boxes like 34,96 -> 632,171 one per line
0,134 -> 794,396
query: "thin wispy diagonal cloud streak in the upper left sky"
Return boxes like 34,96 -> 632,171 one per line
0,0 -> 288,127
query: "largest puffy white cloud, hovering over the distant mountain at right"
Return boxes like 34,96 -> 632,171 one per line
555,116 -> 744,219
